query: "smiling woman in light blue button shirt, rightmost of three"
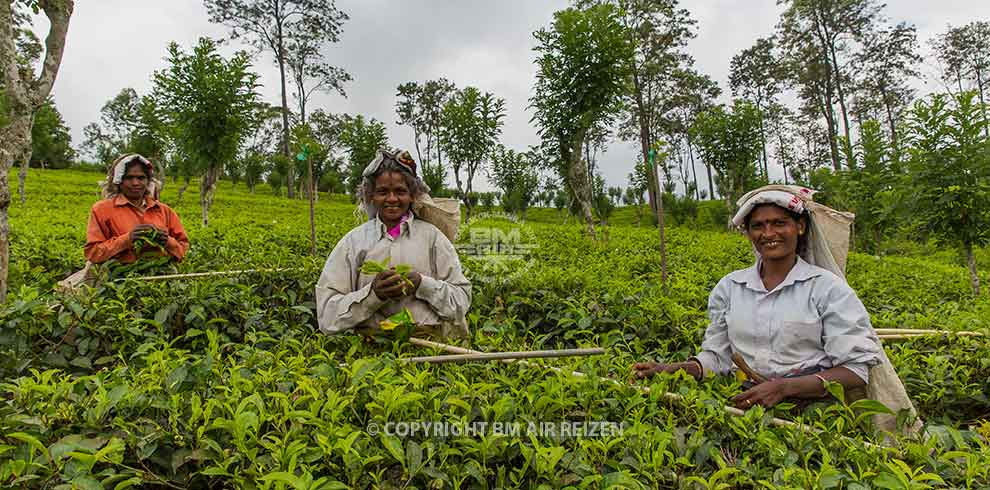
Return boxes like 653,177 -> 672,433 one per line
633,190 -> 882,409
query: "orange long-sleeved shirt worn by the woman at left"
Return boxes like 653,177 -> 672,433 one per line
85,195 -> 189,264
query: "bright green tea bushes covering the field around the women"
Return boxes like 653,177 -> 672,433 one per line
0,167 -> 990,489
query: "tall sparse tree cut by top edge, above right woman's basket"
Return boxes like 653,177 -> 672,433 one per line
777,0 -> 883,166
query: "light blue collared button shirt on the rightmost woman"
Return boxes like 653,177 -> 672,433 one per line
696,257 -> 882,381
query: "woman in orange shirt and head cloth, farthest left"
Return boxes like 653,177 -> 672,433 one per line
85,154 -> 189,264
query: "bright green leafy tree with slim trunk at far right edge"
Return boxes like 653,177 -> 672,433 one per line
902,92 -> 990,295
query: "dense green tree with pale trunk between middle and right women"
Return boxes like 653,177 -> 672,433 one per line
530,5 -> 634,236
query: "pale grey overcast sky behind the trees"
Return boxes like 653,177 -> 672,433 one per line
44,0 -> 990,190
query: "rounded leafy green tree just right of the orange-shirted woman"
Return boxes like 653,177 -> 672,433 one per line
154,37 -> 260,226
